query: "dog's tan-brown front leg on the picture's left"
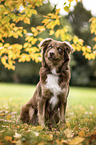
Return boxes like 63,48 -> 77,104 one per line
38,100 -> 45,127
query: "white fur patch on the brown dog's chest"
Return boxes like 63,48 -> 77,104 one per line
45,74 -> 62,109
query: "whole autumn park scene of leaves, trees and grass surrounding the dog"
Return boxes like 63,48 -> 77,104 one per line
0,0 -> 96,145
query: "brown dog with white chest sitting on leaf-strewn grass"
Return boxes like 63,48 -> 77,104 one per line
20,38 -> 73,126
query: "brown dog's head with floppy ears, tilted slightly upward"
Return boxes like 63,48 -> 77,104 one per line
40,38 -> 73,67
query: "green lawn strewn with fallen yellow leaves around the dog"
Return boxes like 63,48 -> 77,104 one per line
0,83 -> 96,145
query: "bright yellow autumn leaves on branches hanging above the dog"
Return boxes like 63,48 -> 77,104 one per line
0,0 -> 96,70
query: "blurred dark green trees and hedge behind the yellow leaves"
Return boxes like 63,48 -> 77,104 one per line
0,1 -> 96,87
